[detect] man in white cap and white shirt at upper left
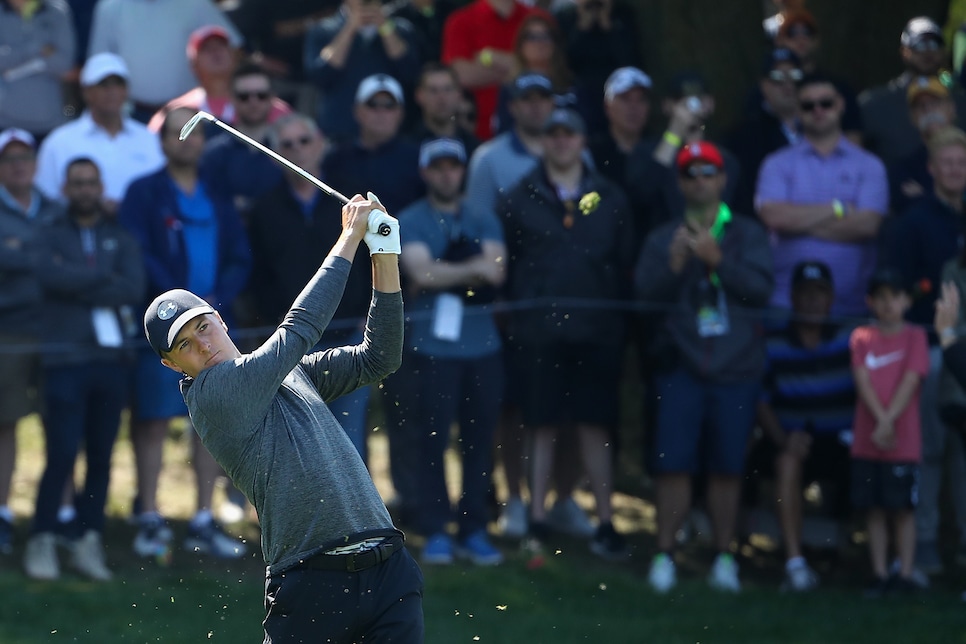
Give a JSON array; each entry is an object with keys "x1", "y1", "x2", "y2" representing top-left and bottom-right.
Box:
[{"x1": 37, "y1": 53, "x2": 164, "y2": 213}]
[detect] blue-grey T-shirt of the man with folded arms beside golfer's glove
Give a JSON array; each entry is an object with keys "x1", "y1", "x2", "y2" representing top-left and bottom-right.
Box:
[{"x1": 399, "y1": 199, "x2": 503, "y2": 358}]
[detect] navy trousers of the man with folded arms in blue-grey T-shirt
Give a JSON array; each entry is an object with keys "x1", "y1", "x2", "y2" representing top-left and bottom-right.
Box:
[{"x1": 413, "y1": 353, "x2": 504, "y2": 537}]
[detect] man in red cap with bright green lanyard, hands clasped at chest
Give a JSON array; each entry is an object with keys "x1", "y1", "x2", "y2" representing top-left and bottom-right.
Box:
[{"x1": 634, "y1": 141, "x2": 773, "y2": 593}]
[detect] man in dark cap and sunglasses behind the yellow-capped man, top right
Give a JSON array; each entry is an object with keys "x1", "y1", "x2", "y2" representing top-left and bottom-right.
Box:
[{"x1": 859, "y1": 16, "x2": 966, "y2": 166}]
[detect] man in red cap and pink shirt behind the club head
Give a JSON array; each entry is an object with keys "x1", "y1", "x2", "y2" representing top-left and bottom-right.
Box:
[{"x1": 148, "y1": 25, "x2": 292, "y2": 132}]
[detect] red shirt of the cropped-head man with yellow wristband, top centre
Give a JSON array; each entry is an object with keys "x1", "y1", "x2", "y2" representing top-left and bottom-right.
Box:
[{"x1": 443, "y1": 0, "x2": 553, "y2": 141}]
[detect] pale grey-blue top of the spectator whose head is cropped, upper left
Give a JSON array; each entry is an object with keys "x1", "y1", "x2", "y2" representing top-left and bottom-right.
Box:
[{"x1": 87, "y1": 0, "x2": 242, "y2": 105}]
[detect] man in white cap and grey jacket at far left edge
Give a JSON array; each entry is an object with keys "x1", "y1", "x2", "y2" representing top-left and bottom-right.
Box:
[{"x1": 0, "y1": 128, "x2": 64, "y2": 552}]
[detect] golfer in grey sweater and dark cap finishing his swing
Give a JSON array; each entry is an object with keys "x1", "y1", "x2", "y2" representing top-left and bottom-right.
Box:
[{"x1": 144, "y1": 193, "x2": 423, "y2": 644}]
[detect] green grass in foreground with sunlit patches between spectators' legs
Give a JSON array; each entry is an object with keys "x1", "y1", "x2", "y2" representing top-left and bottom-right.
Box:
[{"x1": 0, "y1": 412, "x2": 966, "y2": 644}]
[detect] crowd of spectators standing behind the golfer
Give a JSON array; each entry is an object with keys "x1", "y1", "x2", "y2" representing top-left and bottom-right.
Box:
[{"x1": 0, "y1": 0, "x2": 966, "y2": 595}]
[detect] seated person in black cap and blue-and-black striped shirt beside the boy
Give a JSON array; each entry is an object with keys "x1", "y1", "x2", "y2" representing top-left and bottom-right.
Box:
[{"x1": 747, "y1": 260, "x2": 855, "y2": 592}]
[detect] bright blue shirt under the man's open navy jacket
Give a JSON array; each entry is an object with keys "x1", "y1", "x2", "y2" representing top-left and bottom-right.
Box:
[{"x1": 172, "y1": 181, "x2": 218, "y2": 296}]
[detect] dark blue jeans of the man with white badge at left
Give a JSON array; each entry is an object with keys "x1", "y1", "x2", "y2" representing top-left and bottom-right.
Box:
[{"x1": 31, "y1": 362, "x2": 131, "y2": 534}]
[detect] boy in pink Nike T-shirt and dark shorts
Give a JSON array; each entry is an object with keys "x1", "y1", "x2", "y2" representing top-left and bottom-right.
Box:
[{"x1": 849, "y1": 269, "x2": 929, "y2": 596}]
